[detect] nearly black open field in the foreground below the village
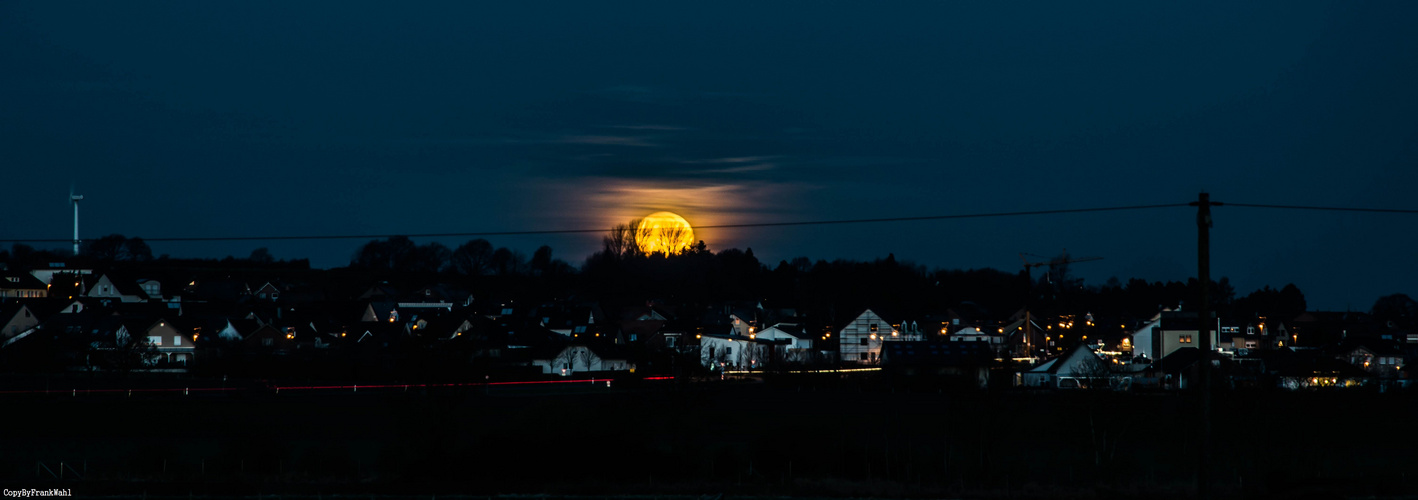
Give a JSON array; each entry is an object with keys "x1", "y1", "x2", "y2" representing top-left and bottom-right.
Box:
[{"x1": 0, "y1": 373, "x2": 1418, "y2": 499}]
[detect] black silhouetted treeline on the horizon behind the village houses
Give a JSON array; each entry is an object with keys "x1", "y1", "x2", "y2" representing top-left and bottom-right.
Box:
[{"x1": 0, "y1": 235, "x2": 1418, "y2": 332}]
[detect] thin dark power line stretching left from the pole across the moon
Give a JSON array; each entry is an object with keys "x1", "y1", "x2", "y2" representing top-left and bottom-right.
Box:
[{"x1": 0, "y1": 203, "x2": 1187, "y2": 244}]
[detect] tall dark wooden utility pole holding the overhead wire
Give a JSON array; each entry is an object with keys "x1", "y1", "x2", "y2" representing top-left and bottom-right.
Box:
[{"x1": 1191, "y1": 193, "x2": 1219, "y2": 500}]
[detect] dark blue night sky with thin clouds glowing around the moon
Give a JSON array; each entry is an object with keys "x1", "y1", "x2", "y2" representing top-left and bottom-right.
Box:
[{"x1": 0, "y1": 1, "x2": 1418, "y2": 310}]
